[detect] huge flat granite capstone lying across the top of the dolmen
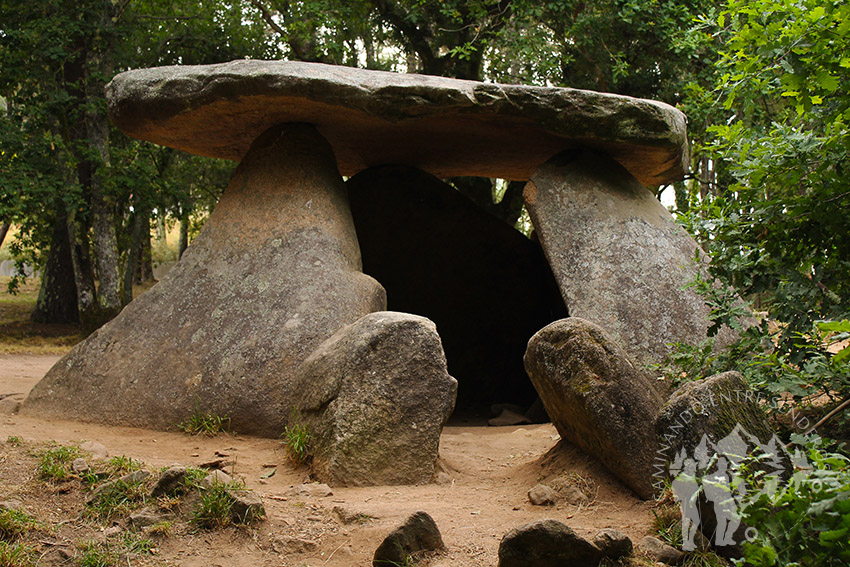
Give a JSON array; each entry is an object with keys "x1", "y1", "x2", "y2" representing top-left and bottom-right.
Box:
[{"x1": 106, "y1": 60, "x2": 687, "y2": 185}]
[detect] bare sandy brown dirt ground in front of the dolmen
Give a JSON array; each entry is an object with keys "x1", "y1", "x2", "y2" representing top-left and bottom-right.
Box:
[{"x1": 0, "y1": 355, "x2": 653, "y2": 567}]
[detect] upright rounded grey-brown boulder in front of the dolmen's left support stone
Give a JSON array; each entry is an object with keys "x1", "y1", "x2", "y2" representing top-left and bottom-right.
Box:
[{"x1": 294, "y1": 312, "x2": 457, "y2": 486}]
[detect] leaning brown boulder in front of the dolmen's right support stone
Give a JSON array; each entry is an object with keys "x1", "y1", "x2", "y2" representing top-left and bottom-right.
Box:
[{"x1": 525, "y1": 317, "x2": 664, "y2": 498}]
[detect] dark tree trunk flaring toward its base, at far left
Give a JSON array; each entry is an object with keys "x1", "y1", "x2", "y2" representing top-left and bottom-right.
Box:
[{"x1": 30, "y1": 207, "x2": 80, "y2": 324}]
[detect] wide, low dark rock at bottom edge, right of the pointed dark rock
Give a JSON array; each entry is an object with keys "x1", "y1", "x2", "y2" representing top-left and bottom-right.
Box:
[{"x1": 499, "y1": 520, "x2": 602, "y2": 567}]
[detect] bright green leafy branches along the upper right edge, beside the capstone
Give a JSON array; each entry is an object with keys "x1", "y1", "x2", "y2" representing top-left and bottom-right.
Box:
[{"x1": 685, "y1": 0, "x2": 850, "y2": 364}]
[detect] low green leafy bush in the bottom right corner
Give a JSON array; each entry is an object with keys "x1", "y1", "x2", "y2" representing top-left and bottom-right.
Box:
[{"x1": 728, "y1": 439, "x2": 850, "y2": 567}]
